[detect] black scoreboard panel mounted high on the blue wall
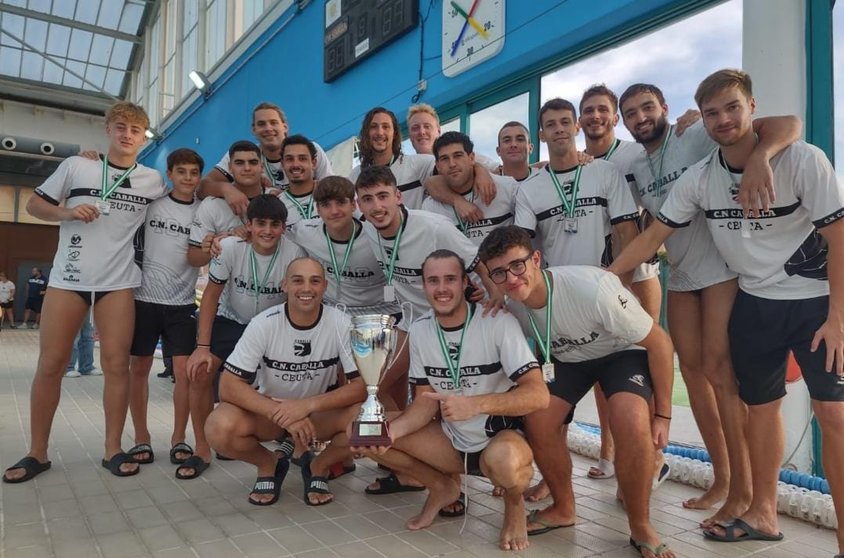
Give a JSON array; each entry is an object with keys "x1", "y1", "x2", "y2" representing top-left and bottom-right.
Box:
[{"x1": 323, "y1": 0, "x2": 419, "y2": 83}]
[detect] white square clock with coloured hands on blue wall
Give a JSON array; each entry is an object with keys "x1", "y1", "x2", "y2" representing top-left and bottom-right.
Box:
[{"x1": 442, "y1": 0, "x2": 504, "y2": 77}]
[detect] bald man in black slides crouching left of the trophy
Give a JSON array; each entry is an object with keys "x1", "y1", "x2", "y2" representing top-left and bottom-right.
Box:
[{"x1": 205, "y1": 258, "x2": 365, "y2": 506}]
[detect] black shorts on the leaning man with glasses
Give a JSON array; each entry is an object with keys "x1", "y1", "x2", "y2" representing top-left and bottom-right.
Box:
[{"x1": 548, "y1": 349, "x2": 653, "y2": 424}]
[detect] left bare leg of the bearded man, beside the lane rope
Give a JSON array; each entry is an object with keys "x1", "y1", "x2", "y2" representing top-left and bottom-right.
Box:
[{"x1": 668, "y1": 291, "x2": 730, "y2": 509}]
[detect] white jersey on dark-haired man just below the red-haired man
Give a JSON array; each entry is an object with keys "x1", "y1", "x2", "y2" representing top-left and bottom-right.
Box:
[{"x1": 422, "y1": 175, "x2": 519, "y2": 246}]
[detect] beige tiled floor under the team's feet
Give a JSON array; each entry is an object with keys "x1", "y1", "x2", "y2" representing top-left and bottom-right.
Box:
[{"x1": 0, "y1": 329, "x2": 836, "y2": 558}]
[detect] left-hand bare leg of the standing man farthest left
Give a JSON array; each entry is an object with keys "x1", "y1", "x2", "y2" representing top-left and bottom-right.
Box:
[{"x1": 6, "y1": 287, "x2": 88, "y2": 480}]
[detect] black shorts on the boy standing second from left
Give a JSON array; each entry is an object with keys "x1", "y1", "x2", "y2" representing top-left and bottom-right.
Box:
[{"x1": 130, "y1": 300, "x2": 196, "y2": 357}]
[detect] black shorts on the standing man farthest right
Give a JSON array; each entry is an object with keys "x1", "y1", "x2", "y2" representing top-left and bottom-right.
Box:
[{"x1": 729, "y1": 290, "x2": 844, "y2": 405}]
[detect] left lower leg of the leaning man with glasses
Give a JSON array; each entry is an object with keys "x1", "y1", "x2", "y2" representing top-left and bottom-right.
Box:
[{"x1": 525, "y1": 396, "x2": 576, "y2": 532}]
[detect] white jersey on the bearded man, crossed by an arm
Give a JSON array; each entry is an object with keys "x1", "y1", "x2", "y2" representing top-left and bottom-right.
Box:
[{"x1": 631, "y1": 121, "x2": 736, "y2": 291}]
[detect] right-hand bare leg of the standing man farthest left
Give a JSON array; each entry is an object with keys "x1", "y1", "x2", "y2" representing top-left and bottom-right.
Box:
[{"x1": 94, "y1": 289, "x2": 138, "y2": 471}]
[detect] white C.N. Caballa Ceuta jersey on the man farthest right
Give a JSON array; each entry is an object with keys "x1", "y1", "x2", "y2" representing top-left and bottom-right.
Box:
[{"x1": 658, "y1": 141, "x2": 844, "y2": 300}]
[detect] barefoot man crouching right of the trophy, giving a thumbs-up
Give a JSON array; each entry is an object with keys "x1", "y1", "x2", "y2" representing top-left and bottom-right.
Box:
[{"x1": 350, "y1": 250, "x2": 549, "y2": 550}]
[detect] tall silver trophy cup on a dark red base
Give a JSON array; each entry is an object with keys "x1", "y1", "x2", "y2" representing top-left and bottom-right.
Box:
[{"x1": 349, "y1": 314, "x2": 397, "y2": 447}]
